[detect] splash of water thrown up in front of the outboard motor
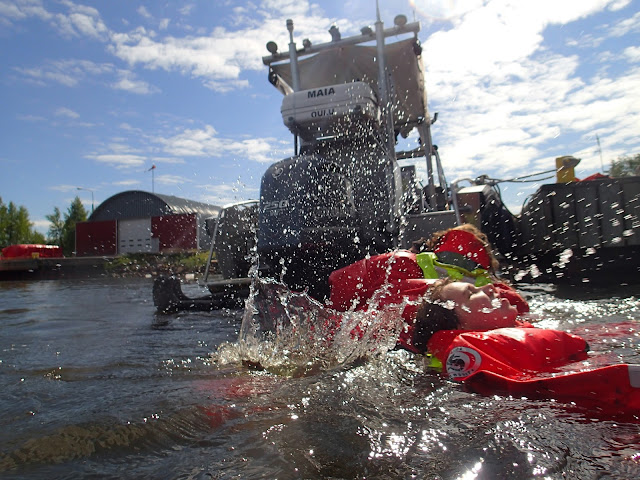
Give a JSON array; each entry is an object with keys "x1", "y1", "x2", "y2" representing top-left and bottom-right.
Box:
[{"x1": 213, "y1": 278, "x2": 405, "y2": 376}]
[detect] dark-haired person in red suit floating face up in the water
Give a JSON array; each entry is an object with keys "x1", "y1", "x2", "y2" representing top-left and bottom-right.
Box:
[{"x1": 413, "y1": 280, "x2": 640, "y2": 412}]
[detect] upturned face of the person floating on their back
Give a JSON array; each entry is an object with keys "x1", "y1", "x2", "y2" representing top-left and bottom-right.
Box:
[{"x1": 441, "y1": 282, "x2": 518, "y2": 330}]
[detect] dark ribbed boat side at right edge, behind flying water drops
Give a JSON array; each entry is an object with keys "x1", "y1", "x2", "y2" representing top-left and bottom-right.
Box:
[{"x1": 503, "y1": 175, "x2": 640, "y2": 285}]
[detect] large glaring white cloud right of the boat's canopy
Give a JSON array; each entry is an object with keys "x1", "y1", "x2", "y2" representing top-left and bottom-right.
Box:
[{"x1": 424, "y1": 0, "x2": 640, "y2": 188}]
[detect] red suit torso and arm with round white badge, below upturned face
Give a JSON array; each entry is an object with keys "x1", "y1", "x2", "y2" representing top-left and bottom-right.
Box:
[{"x1": 428, "y1": 328, "x2": 640, "y2": 414}]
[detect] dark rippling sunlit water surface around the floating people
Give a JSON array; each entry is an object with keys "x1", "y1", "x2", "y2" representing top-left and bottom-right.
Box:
[{"x1": 0, "y1": 278, "x2": 640, "y2": 480}]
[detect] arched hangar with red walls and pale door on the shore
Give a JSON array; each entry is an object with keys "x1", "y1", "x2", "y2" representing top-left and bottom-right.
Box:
[{"x1": 76, "y1": 190, "x2": 221, "y2": 256}]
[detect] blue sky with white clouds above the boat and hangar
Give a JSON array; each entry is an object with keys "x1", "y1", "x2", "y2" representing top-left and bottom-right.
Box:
[{"x1": 0, "y1": 0, "x2": 640, "y2": 234}]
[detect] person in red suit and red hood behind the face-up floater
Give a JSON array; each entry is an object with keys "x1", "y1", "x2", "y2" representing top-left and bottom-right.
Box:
[{"x1": 329, "y1": 225, "x2": 529, "y2": 353}]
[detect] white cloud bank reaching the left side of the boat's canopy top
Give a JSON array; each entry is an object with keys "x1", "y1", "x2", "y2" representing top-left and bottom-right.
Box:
[{"x1": 108, "y1": 0, "x2": 344, "y2": 93}]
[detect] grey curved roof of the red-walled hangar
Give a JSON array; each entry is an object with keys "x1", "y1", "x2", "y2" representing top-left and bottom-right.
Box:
[{"x1": 89, "y1": 190, "x2": 221, "y2": 222}]
